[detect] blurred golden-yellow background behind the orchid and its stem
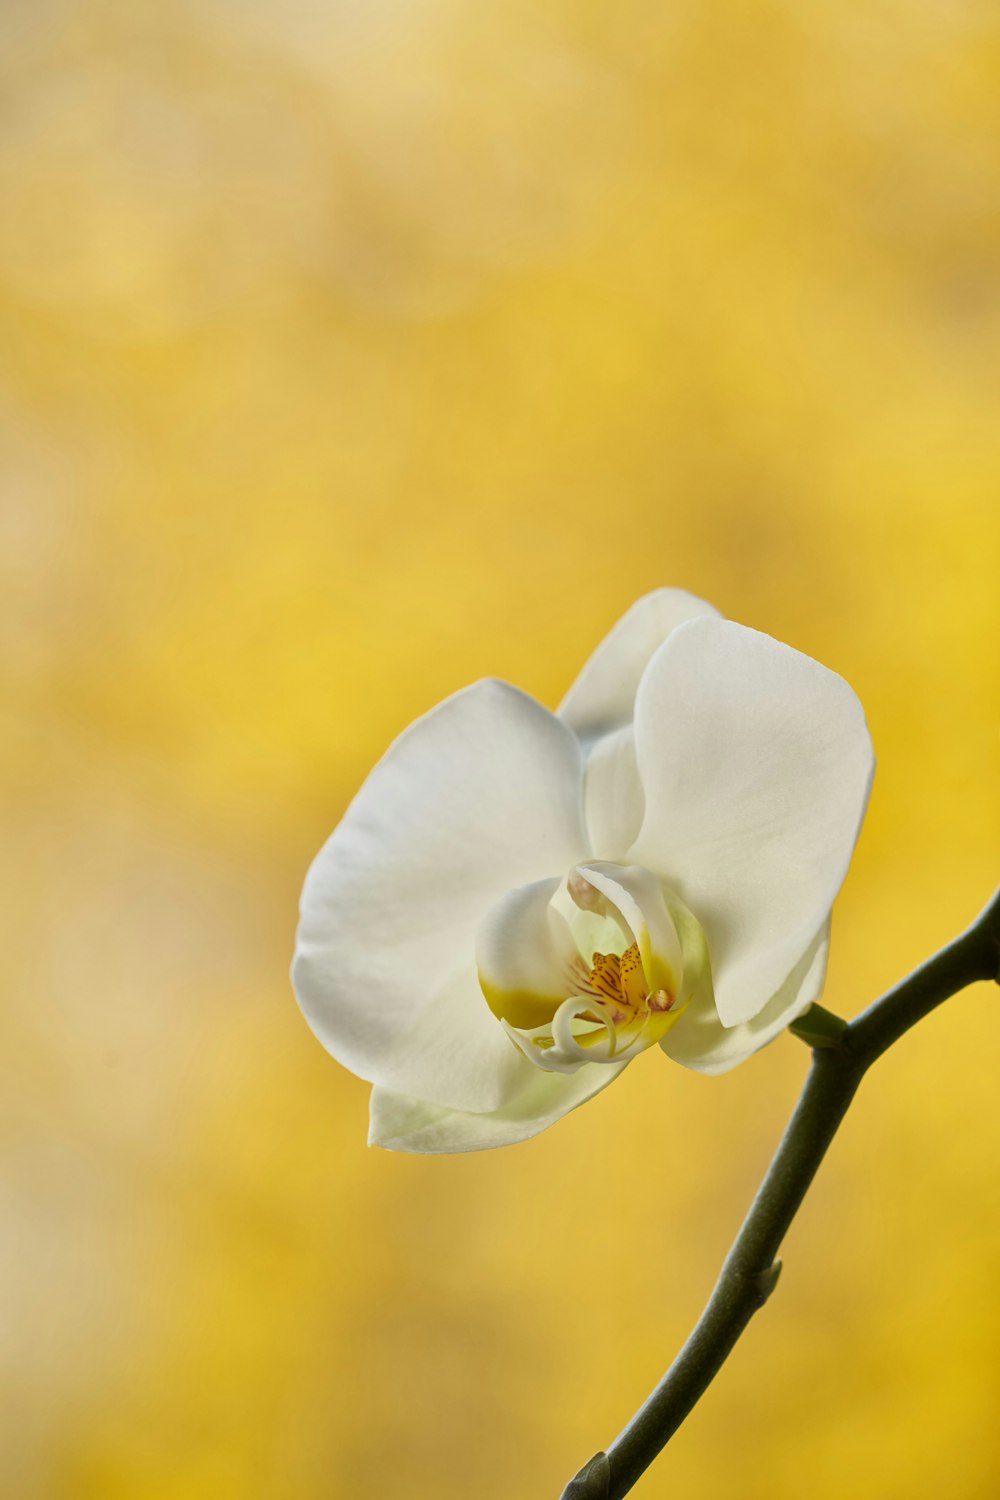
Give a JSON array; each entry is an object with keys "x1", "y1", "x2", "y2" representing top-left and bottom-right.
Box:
[{"x1": 0, "y1": 0, "x2": 1000, "y2": 1500}]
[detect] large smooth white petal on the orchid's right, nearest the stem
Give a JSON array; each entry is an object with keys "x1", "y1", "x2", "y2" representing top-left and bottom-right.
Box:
[{"x1": 630, "y1": 620, "x2": 874, "y2": 1026}]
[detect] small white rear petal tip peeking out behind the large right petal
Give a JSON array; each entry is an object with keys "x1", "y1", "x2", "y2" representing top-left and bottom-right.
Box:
[{"x1": 559, "y1": 588, "x2": 718, "y2": 738}]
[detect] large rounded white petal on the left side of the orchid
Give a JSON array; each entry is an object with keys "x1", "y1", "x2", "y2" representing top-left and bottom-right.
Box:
[{"x1": 292, "y1": 681, "x2": 586, "y2": 1110}]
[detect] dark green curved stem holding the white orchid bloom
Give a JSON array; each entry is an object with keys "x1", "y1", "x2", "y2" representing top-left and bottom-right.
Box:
[{"x1": 564, "y1": 891, "x2": 1000, "y2": 1500}]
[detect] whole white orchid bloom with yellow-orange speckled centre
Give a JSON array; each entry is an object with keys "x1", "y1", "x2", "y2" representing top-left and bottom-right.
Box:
[{"x1": 292, "y1": 590, "x2": 874, "y2": 1152}]
